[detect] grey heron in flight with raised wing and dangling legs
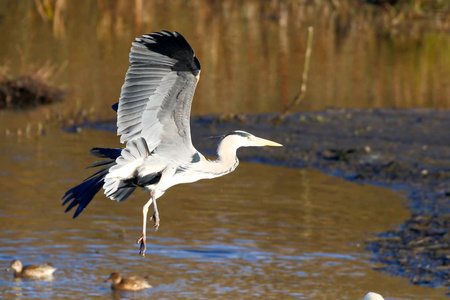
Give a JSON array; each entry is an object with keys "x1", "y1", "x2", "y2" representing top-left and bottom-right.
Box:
[{"x1": 62, "y1": 31, "x2": 282, "y2": 256}]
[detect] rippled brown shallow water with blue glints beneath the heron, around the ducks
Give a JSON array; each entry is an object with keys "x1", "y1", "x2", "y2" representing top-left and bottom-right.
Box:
[{"x1": 0, "y1": 130, "x2": 446, "y2": 299}]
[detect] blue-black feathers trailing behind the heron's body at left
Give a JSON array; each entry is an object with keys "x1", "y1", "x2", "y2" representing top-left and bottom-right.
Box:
[{"x1": 62, "y1": 148, "x2": 135, "y2": 218}]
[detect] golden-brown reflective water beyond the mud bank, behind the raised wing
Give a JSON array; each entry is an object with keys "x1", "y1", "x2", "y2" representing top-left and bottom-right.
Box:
[{"x1": 0, "y1": 0, "x2": 450, "y2": 129}]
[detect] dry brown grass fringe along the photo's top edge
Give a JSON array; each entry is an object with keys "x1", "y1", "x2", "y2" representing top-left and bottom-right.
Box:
[{"x1": 29, "y1": 0, "x2": 450, "y2": 37}]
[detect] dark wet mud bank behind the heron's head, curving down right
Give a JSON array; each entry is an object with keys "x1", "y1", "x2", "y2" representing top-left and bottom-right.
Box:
[{"x1": 77, "y1": 109, "x2": 450, "y2": 286}]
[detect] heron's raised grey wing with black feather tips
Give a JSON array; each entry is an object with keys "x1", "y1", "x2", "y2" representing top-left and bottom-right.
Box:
[{"x1": 117, "y1": 31, "x2": 200, "y2": 157}]
